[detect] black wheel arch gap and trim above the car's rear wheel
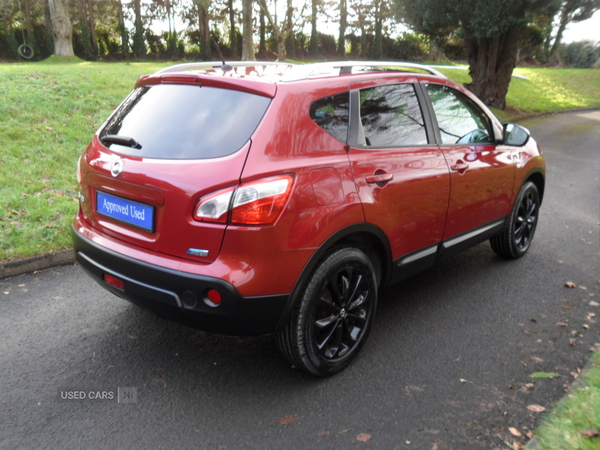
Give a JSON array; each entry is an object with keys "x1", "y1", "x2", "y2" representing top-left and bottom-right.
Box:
[{"x1": 277, "y1": 223, "x2": 392, "y2": 331}]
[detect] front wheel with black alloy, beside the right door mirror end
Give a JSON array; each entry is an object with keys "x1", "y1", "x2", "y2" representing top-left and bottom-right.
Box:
[{"x1": 490, "y1": 181, "x2": 540, "y2": 259}]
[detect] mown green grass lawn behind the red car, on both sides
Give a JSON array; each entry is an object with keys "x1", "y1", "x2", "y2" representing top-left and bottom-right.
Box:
[{"x1": 0, "y1": 57, "x2": 600, "y2": 261}]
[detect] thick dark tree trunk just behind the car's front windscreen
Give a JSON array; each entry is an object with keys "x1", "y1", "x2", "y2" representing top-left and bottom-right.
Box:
[{"x1": 465, "y1": 29, "x2": 520, "y2": 110}]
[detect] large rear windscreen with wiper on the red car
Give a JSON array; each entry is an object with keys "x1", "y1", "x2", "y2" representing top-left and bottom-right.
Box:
[{"x1": 99, "y1": 84, "x2": 271, "y2": 159}]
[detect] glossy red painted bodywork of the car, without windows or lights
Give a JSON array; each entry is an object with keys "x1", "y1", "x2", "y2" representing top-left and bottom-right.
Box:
[{"x1": 74, "y1": 63, "x2": 543, "y2": 302}]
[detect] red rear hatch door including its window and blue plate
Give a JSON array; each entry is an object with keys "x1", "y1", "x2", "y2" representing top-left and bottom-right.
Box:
[{"x1": 80, "y1": 84, "x2": 270, "y2": 262}]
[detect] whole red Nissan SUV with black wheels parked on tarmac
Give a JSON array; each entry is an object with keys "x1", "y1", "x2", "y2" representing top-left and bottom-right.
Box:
[{"x1": 73, "y1": 61, "x2": 545, "y2": 375}]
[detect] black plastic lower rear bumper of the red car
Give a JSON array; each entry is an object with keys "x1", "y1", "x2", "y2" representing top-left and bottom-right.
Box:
[{"x1": 71, "y1": 227, "x2": 289, "y2": 335}]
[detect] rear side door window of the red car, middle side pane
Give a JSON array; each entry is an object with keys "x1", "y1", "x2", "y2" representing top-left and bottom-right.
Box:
[{"x1": 360, "y1": 84, "x2": 427, "y2": 147}]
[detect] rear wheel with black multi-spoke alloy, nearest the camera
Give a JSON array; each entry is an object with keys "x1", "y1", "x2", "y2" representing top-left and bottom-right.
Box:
[{"x1": 276, "y1": 248, "x2": 377, "y2": 376}]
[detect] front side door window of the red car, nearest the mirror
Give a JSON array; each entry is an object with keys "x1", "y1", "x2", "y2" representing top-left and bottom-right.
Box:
[{"x1": 427, "y1": 84, "x2": 493, "y2": 144}]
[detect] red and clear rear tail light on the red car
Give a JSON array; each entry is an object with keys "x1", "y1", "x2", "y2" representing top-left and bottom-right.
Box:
[{"x1": 194, "y1": 175, "x2": 294, "y2": 225}]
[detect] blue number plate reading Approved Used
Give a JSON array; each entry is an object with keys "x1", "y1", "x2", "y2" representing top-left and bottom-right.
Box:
[{"x1": 96, "y1": 191, "x2": 154, "y2": 232}]
